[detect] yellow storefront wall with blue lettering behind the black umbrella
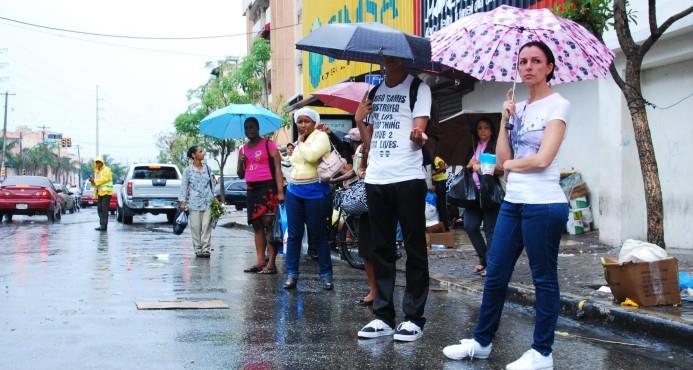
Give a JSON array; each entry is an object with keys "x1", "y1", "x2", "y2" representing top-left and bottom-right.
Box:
[{"x1": 303, "y1": 0, "x2": 414, "y2": 114}]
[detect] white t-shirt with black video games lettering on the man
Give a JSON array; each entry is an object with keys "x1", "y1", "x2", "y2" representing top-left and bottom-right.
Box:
[{"x1": 365, "y1": 75, "x2": 431, "y2": 184}]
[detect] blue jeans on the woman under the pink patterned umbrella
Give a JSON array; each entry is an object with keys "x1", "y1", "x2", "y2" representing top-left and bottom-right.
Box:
[{"x1": 474, "y1": 202, "x2": 568, "y2": 356}]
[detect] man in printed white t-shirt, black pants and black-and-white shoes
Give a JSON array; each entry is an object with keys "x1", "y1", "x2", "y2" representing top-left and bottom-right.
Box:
[{"x1": 355, "y1": 57, "x2": 431, "y2": 342}]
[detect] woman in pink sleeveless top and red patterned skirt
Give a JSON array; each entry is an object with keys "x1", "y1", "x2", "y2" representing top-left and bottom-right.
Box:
[{"x1": 237, "y1": 117, "x2": 284, "y2": 274}]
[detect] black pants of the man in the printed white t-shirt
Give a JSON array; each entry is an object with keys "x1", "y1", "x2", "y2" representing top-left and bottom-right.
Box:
[{"x1": 366, "y1": 180, "x2": 429, "y2": 328}]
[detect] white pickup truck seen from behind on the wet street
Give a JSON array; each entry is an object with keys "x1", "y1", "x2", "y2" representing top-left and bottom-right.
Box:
[{"x1": 116, "y1": 163, "x2": 181, "y2": 225}]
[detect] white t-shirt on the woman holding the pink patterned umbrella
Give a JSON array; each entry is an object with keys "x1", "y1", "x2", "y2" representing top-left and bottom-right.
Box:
[{"x1": 505, "y1": 93, "x2": 570, "y2": 204}]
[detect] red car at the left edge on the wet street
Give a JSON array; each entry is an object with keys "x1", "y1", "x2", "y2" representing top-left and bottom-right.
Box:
[{"x1": 0, "y1": 176, "x2": 60, "y2": 222}]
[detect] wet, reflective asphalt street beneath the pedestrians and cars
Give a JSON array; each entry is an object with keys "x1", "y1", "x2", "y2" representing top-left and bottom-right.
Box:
[{"x1": 0, "y1": 208, "x2": 693, "y2": 369}]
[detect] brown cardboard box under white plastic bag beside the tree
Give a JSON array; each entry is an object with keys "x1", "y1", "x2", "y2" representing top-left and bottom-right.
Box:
[{"x1": 602, "y1": 256, "x2": 681, "y2": 306}]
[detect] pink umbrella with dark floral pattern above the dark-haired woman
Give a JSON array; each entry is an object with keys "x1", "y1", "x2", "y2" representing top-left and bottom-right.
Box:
[{"x1": 430, "y1": 5, "x2": 614, "y2": 84}]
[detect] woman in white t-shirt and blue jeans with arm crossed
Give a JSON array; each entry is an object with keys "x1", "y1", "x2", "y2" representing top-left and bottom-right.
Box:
[{"x1": 443, "y1": 41, "x2": 570, "y2": 369}]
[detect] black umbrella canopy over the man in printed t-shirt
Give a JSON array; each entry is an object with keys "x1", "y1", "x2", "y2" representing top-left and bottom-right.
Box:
[{"x1": 296, "y1": 23, "x2": 433, "y2": 69}]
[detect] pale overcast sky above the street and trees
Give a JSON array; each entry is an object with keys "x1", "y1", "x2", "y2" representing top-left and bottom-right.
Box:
[{"x1": 0, "y1": 0, "x2": 246, "y2": 163}]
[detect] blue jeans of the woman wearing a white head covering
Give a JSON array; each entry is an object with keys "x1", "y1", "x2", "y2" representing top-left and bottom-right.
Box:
[{"x1": 284, "y1": 191, "x2": 332, "y2": 281}]
